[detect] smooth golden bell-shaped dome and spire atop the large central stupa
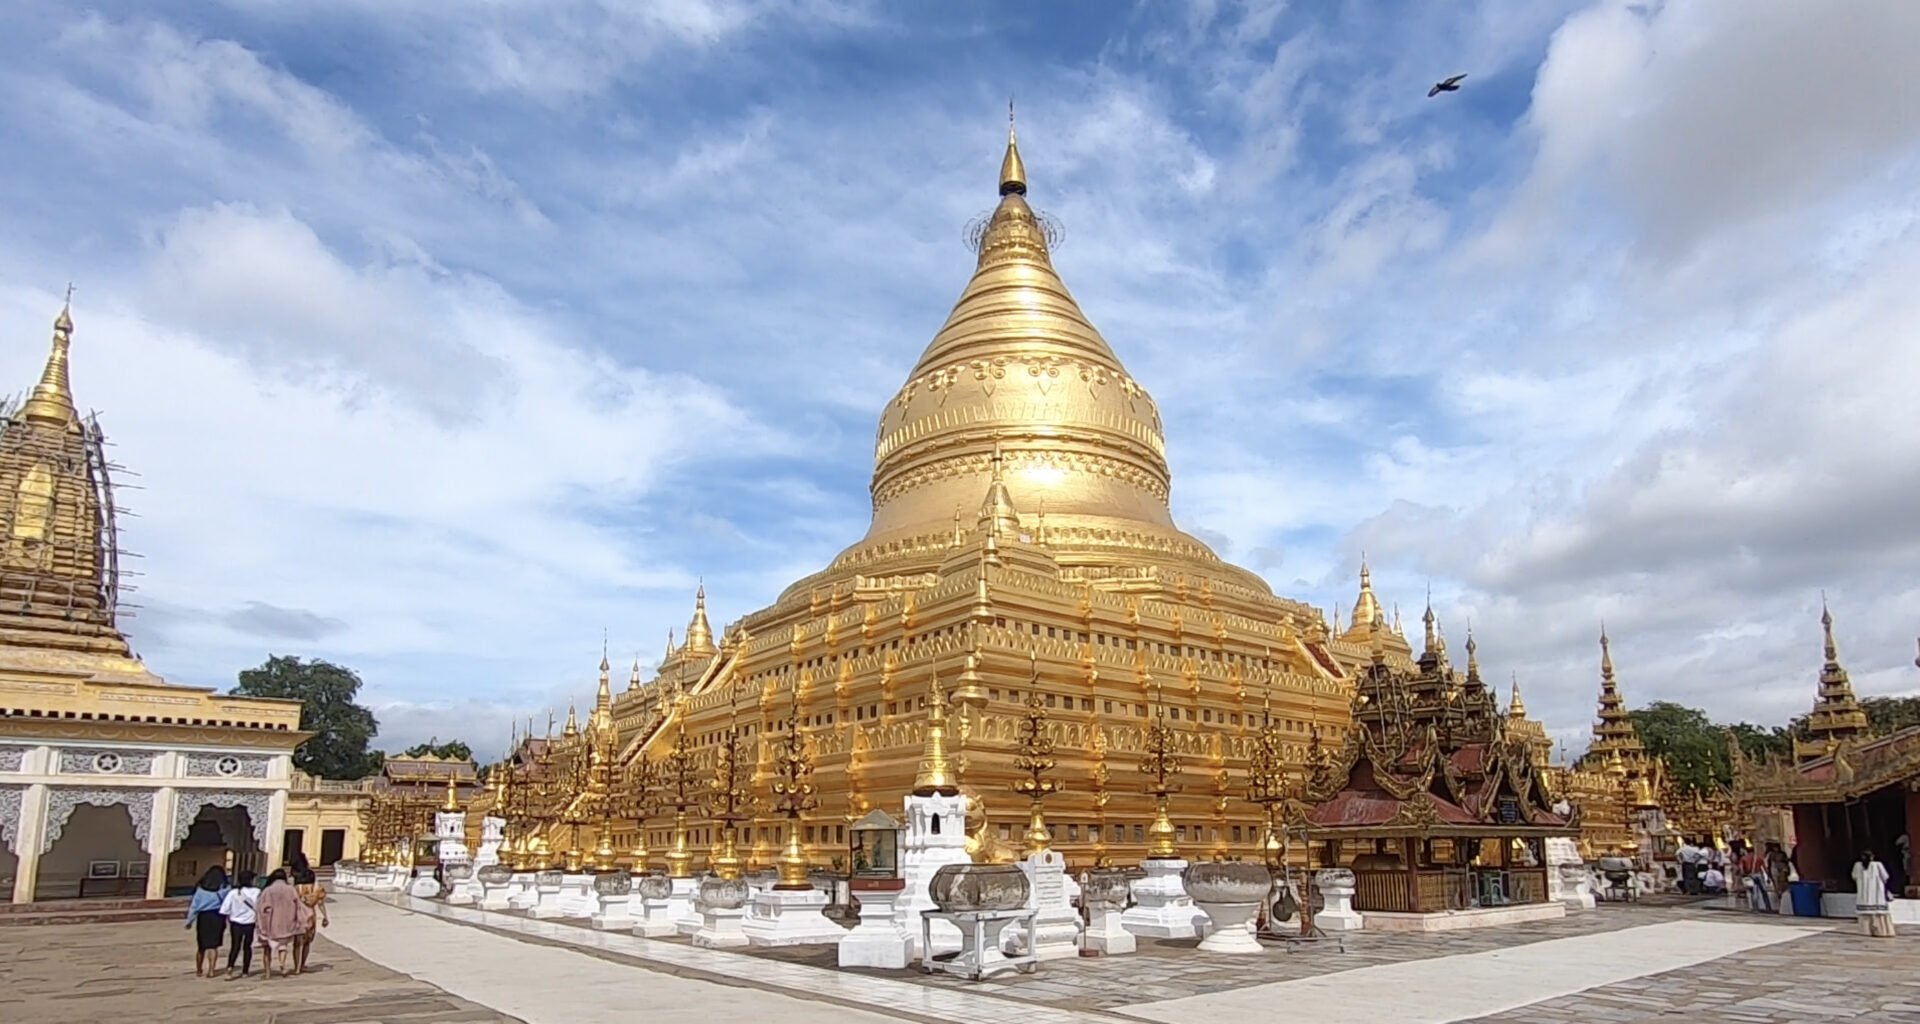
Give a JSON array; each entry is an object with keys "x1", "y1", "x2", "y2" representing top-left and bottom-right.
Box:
[{"x1": 797, "y1": 125, "x2": 1269, "y2": 594}]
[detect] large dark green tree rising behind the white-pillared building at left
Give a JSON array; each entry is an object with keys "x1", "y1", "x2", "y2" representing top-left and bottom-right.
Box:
[{"x1": 232, "y1": 655, "x2": 380, "y2": 780}]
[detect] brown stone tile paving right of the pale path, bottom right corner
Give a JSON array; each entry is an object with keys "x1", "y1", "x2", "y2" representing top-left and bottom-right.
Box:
[{"x1": 1451, "y1": 922, "x2": 1920, "y2": 1024}]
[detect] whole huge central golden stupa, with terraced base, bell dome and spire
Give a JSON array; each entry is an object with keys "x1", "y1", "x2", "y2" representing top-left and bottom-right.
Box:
[{"x1": 526, "y1": 123, "x2": 1409, "y2": 866}]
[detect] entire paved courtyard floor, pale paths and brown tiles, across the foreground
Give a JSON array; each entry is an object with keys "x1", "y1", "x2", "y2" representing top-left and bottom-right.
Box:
[{"x1": 0, "y1": 895, "x2": 1920, "y2": 1024}]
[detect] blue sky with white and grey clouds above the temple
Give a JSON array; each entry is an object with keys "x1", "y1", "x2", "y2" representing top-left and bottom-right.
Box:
[{"x1": 0, "y1": 0, "x2": 1920, "y2": 749}]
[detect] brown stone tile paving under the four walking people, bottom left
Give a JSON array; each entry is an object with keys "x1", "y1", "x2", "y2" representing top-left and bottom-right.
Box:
[{"x1": 0, "y1": 920, "x2": 518, "y2": 1024}]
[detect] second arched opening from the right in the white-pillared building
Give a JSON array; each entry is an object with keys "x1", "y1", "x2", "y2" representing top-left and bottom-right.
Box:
[{"x1": 33, "y1": 790, "x2": 154, "y2": 899}]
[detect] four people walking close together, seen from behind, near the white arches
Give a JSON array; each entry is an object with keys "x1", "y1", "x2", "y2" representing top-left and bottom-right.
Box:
[{"x1": 186, "y1": 853, "x2": 328, "y2": 978}]
